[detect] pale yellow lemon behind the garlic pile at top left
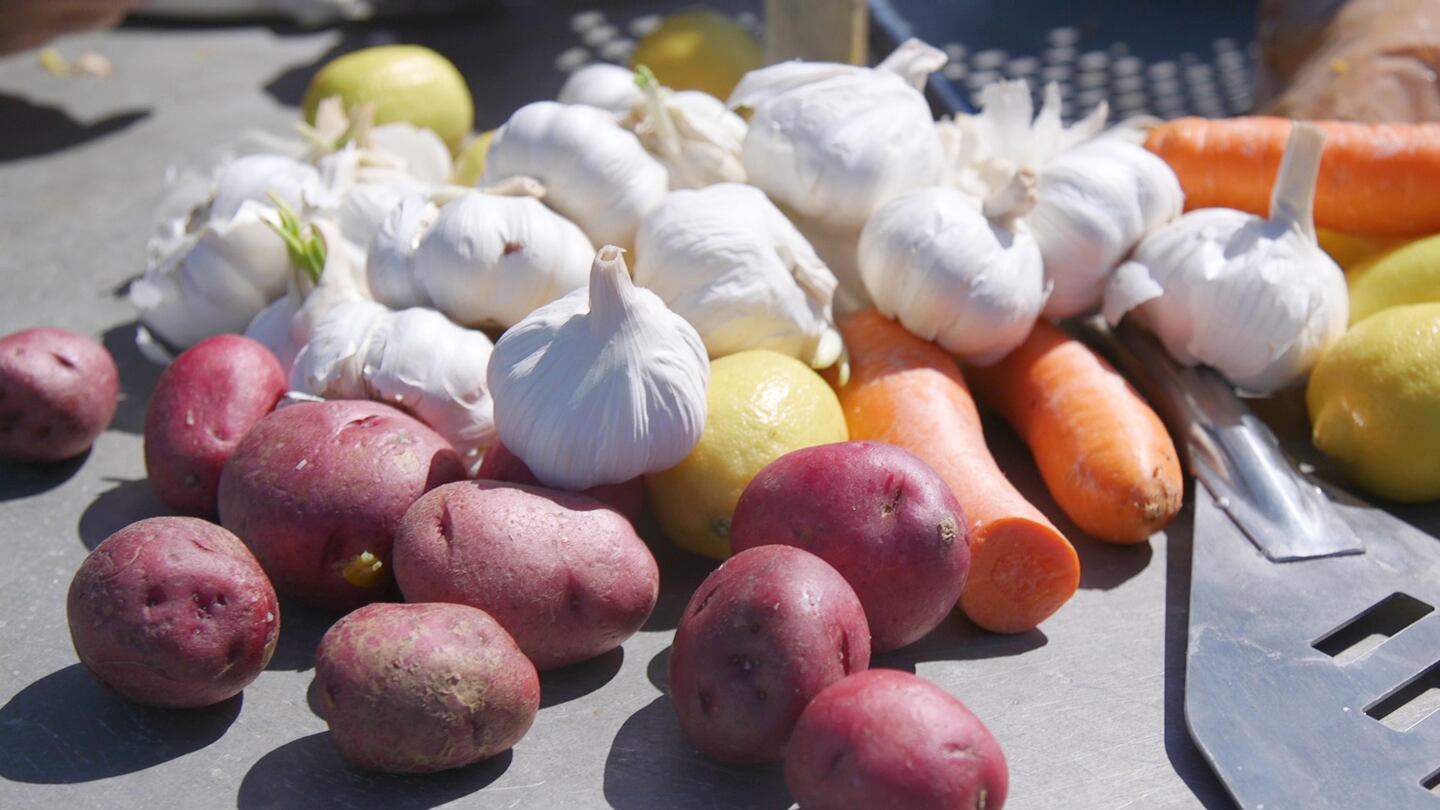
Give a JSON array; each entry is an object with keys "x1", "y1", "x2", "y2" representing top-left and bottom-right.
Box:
[{"x1": 302, "y1": 45, "x2": 475, "y2": 151}]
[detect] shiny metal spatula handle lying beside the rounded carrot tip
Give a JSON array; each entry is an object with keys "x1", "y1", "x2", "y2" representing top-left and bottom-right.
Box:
[{"x1": 1086, "y1": 321, "x2": 1364, "y2": 562}]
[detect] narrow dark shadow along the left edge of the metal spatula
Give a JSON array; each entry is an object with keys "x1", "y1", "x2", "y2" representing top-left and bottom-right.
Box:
[{"x1": 1164, "y1": 502, "x2": 1234, "y2": 810}]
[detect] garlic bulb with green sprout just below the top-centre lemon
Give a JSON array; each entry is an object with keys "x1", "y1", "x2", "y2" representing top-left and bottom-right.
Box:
[{"x1": 622, "y1": 68, "x2": 747, "y2": 189}]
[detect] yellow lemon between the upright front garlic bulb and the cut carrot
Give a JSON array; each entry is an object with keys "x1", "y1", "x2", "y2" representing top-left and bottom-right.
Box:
[{"x1": 645, "y1": 349, "x2": 850, "y2": 559}]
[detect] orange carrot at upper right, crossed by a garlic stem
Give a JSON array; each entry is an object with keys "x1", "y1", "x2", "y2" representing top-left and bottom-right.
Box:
[{"x1": 1145, "y1": 117, "x2": 1440, "y2": 236}]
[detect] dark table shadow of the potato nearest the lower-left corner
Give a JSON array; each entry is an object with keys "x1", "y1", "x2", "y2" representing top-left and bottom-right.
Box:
[{"x1": 0, "y1": 663, "x2": 242, "y2": 784}]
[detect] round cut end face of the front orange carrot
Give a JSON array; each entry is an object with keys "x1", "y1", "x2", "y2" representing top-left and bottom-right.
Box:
[{"x1": 960, "y1": 517, "x2": 1080, "y2": 633}]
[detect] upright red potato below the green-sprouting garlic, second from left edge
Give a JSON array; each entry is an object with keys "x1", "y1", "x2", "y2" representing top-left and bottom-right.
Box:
[{"x1": 145, "y1": 334, "x2": 285, "y2": 517}]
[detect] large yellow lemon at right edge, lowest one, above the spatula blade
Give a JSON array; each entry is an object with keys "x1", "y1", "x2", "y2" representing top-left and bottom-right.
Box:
[{"x1": 1305, "y1": 304, "x2": 1440, "y2": 502}]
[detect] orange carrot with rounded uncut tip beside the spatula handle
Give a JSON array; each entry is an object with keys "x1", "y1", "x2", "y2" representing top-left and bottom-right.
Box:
[{"x1": 965, "y1": 321, "x2": 1185, "y2": 543}]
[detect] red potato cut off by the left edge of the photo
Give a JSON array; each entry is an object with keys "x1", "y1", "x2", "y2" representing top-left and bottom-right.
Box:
[{"x1": 0, "y1": 327, "x2": 120, "y2": 463}]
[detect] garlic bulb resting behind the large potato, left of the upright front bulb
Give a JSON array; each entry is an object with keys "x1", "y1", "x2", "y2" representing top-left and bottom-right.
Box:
[{"x1": 289, "y1": 301, "x2": 495, "y2": 473}]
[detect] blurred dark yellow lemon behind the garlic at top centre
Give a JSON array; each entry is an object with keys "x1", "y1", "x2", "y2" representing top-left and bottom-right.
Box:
[{"x1": 631, "y1": 9, "x2": 763, "y2": 101}]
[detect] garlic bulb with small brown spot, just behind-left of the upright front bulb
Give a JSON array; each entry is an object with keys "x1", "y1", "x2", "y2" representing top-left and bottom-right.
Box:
[{"x1": 413, "y1": 192, "x2": 595, "y2": 327}]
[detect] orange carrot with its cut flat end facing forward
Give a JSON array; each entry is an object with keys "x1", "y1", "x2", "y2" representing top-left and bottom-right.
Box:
[{"x1": 837, "y1": 310, "x2": 1080, "y2": 633}]
